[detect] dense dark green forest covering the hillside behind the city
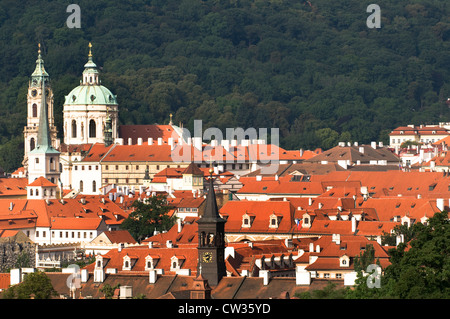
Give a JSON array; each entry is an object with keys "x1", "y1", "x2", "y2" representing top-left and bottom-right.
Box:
[{"x1": 0, "y1": 0, "x2": 450, "y2": 171}]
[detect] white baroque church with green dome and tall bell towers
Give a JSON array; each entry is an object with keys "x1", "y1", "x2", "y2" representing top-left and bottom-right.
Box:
[{"x1": 22, "y1": 43, "x2": 160, "y2": 198}]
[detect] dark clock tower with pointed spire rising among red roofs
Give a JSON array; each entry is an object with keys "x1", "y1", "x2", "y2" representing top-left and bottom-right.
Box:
[{"x1": 197, "y1": 171, "x2": 226, "y2": 286}]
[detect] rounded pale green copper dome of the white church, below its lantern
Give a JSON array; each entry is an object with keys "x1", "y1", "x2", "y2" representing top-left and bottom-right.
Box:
[{"x1": 64, "y1": 84, "x2": 117, "y2": 105}]
